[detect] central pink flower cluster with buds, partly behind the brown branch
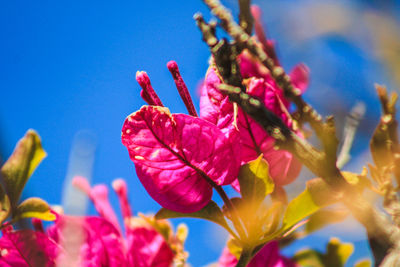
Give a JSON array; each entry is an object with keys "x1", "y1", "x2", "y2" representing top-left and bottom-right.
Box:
[{"x1": 122, "y1": 5, "x2": 308, "y2": 213}]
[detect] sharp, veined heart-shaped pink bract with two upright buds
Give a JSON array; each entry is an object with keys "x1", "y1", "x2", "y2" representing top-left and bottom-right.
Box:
[{"x1": 122, "y1": 61, "x2": 240, "y2": 213}]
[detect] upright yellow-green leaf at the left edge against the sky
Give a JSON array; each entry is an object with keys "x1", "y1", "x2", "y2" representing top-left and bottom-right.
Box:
[{"x1": 1, "y1": 130, "x2": 46, "y2": 207}]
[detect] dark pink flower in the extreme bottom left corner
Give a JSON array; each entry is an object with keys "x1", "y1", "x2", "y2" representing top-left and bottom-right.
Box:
[{"x1": 0, "y1": 227, "x2": 62, "y2": 267}]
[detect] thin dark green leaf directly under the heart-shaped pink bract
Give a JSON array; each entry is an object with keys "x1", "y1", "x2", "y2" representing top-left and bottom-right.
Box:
[{"x1": 155, "y1": 201, "x2": 229, "y2": 229}]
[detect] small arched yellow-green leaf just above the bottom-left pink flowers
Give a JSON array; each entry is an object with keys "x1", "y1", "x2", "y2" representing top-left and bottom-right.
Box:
[{"x1": 13, "y1": 197, "x2": 56, "y2": 221}]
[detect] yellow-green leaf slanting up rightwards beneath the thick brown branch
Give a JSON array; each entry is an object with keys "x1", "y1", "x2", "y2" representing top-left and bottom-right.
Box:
[{"x1": 282, "y1": 178, "x2": 339, "y2": 232}]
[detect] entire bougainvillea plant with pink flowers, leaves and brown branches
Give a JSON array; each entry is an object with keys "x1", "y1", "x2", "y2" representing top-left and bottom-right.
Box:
[{"x1": 0, "y1": 0, "x2": 400, "y2": 267}]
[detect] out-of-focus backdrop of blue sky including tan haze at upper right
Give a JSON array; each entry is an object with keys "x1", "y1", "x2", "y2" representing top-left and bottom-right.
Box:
[{"x1": 0, "y1": 0, "x2": 400, "y2": 266}]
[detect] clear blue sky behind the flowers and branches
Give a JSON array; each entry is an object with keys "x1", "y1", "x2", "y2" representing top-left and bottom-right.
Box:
[{"x1": 0, "y1": 0, "x2": 393, "y2": 266}]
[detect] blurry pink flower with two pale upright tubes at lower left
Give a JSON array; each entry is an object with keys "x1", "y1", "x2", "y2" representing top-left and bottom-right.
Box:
[{"x1": 63, "y1": 177, "x2": 176, "y2": 267}]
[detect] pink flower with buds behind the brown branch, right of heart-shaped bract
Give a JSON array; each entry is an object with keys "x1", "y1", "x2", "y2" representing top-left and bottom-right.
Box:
[{"x1": 200, "y1": 8, "x2": 308, "y2": 188}]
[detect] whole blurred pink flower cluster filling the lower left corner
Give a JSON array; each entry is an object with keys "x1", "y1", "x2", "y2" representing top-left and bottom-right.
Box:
[{"x1": 0, "y1": 177, "x2": 186, "y2": 267}]
